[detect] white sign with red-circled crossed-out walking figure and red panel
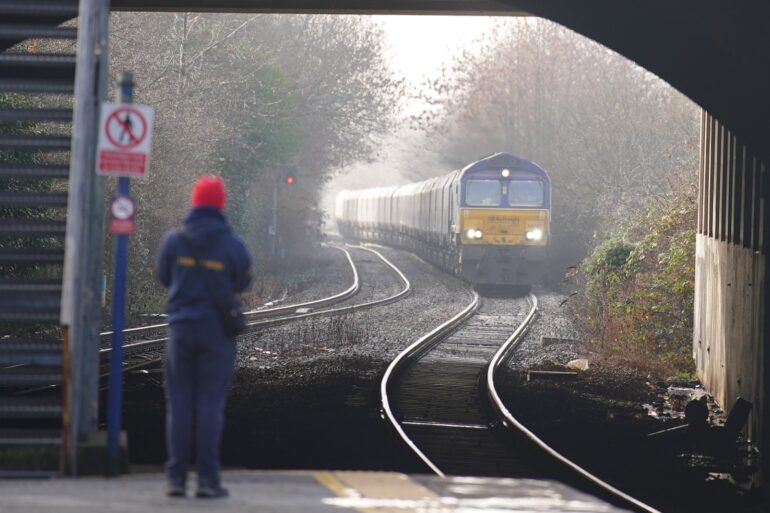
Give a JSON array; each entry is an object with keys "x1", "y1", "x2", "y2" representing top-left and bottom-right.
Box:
[{"x1": 96, "y1": 102, "x2": 154, "y2": 178}]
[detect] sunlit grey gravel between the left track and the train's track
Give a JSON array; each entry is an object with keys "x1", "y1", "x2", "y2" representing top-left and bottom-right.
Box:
[{"x1": 238, "y1": 248, "x2": 471, "y2": 369}]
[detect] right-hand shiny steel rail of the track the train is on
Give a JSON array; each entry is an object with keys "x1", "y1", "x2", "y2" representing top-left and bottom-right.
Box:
[{"x1": 486, "y1": 294, "x2": 660, "y2": 513}]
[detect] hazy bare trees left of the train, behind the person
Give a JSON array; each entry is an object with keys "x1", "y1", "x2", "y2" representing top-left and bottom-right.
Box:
[{"x1": 105, "y1": 13, "x2": 404, "y2": 316}]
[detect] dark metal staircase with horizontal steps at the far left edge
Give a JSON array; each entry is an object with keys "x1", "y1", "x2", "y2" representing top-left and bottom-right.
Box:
[{"x1": 0, "y1": 0, "x2": 78, "y2": 477}]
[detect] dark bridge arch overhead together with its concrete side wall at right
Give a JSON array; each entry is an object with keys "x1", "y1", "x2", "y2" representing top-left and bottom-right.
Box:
[{"x1": 112, "y1": 0, "x2": 770, "y2": 476}]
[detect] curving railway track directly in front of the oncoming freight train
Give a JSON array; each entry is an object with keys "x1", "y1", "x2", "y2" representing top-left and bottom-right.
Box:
[{"x1": 380, "y1": 292, "x2": 658, "y2": 513}]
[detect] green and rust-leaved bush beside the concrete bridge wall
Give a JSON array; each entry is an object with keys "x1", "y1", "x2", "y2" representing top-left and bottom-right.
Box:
[{"x1": 578, "y1": 198, "x2": 696, "y2": 375}]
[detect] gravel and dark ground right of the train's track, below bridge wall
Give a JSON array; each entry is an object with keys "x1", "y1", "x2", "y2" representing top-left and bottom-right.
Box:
[{"x1": 498, "y1": 291, "x2": 763, "y2": 513}]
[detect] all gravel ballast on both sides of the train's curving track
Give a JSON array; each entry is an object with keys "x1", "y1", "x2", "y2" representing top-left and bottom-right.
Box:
[{"x1": 118, "y1": 244, "x2": 759, "y2": 512}]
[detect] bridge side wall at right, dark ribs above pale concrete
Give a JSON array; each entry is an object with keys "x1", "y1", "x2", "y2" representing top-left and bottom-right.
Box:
[{"x1": 693, "y1": 112, "x2": 770, "y2": 482}]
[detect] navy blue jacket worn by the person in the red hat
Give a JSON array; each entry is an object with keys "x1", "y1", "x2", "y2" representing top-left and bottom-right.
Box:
[{"x1": 155, "y1": 207, "x2": 251, "y2": 324}]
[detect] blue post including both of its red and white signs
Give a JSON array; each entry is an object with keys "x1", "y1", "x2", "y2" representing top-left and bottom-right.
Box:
[{"x1": 103, "y1": 71, "x2": 153, "y2": 476}]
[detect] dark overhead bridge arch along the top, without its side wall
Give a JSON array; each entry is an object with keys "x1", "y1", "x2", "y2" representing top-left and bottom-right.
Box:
[{"x1": 111, "y1": 0, "x2": 770, "y2": 162}]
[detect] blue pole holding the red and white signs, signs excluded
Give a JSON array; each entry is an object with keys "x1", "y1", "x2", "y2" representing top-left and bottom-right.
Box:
[{"x1": 107, "y1": 71, "x2": 134, "y2": 476}]
